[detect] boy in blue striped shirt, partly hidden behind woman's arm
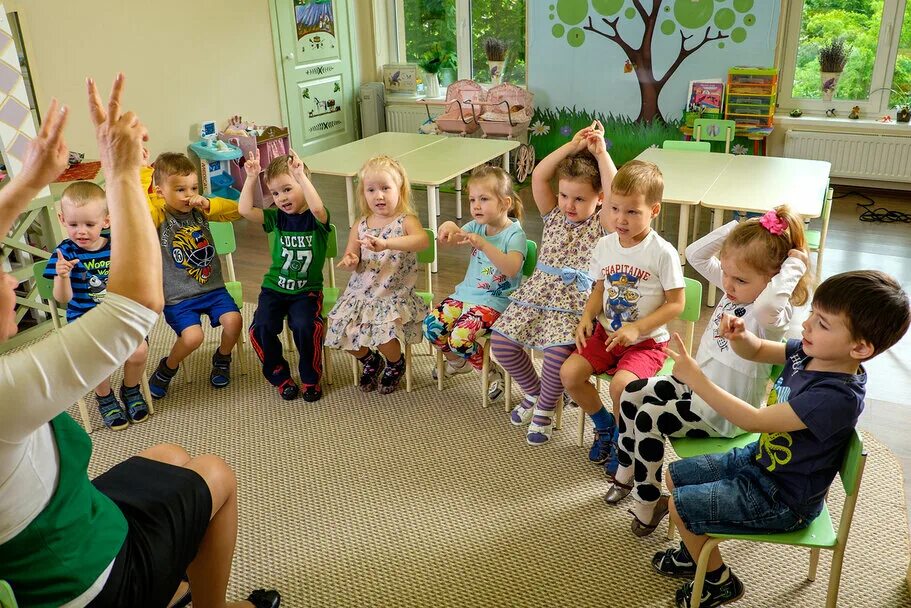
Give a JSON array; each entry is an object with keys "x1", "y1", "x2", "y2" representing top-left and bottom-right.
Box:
[{"x1": 44, "y1": 182, "x2": 149, "y2": 431}]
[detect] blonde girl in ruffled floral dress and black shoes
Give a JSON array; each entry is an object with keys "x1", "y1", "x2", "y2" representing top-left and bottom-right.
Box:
[{"x1": 325, "y1": 156, "x2": 430, "y2": 394}]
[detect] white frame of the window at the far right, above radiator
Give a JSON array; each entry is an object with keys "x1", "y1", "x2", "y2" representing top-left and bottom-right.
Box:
[{"x1": 778, "y1": 0, "x2": 906, "y2": 116}]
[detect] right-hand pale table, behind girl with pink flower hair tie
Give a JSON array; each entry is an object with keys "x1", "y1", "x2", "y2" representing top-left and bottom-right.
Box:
[{"x1": 702, "y1": 156, "x2": 832, "y2": 306}]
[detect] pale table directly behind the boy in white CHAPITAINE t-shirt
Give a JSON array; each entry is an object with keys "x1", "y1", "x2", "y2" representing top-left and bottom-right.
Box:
[{"x1": 636, "y1": 148, "x2": 734, "y2": 264}]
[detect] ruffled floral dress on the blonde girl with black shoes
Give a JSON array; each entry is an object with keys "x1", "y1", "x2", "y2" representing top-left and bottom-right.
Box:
[{"x1": 326, "y1": 215, "x2": 427, "y2": 350}]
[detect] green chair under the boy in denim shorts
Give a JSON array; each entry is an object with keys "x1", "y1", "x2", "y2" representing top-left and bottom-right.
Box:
[{"x1": 692, "y1": 430, "x2": 867, "y2": 608}]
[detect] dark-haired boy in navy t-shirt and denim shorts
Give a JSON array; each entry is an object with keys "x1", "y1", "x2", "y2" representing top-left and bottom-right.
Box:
[{"x1": 652, "y1": 270, "x2": 911, "y2": 608}]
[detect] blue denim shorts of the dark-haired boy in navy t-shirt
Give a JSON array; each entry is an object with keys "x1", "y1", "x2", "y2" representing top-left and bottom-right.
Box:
[{"x1": 668, "y1": 443, "x2": 814, "y2": 534}]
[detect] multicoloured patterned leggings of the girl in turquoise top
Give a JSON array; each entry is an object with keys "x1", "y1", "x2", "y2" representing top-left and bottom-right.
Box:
[{"x1": 424, "y1": 298, "x2": 500, "y2": 369}]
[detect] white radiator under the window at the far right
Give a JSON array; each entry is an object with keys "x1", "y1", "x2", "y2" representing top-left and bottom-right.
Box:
[{"x1": 784, "y1": 130, "x2": 911, "y2": 183}]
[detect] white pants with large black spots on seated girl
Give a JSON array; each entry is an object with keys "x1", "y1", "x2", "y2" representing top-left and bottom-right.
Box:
[{"x1": 615, "y1": 376, "x2": 718, "y2": 511}]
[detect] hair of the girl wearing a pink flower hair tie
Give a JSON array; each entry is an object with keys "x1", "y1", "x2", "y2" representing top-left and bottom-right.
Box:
[{"x1": 720, "y1": 205, "x2": 810, "y2": 306}]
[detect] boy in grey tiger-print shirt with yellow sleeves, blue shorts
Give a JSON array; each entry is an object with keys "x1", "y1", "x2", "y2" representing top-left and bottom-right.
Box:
[{"x1": 140, "y1": 152, "x2": 243, "y2": 399}]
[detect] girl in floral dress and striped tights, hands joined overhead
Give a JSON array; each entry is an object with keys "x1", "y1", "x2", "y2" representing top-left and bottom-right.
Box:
[{"x1": 491, "y1": 121, "x2": 617, "y2": 445}]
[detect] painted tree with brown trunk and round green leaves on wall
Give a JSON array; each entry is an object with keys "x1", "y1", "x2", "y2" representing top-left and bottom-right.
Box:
[{"x1": 550, "y1": 0, "x2": 756, "y2": 122}]
